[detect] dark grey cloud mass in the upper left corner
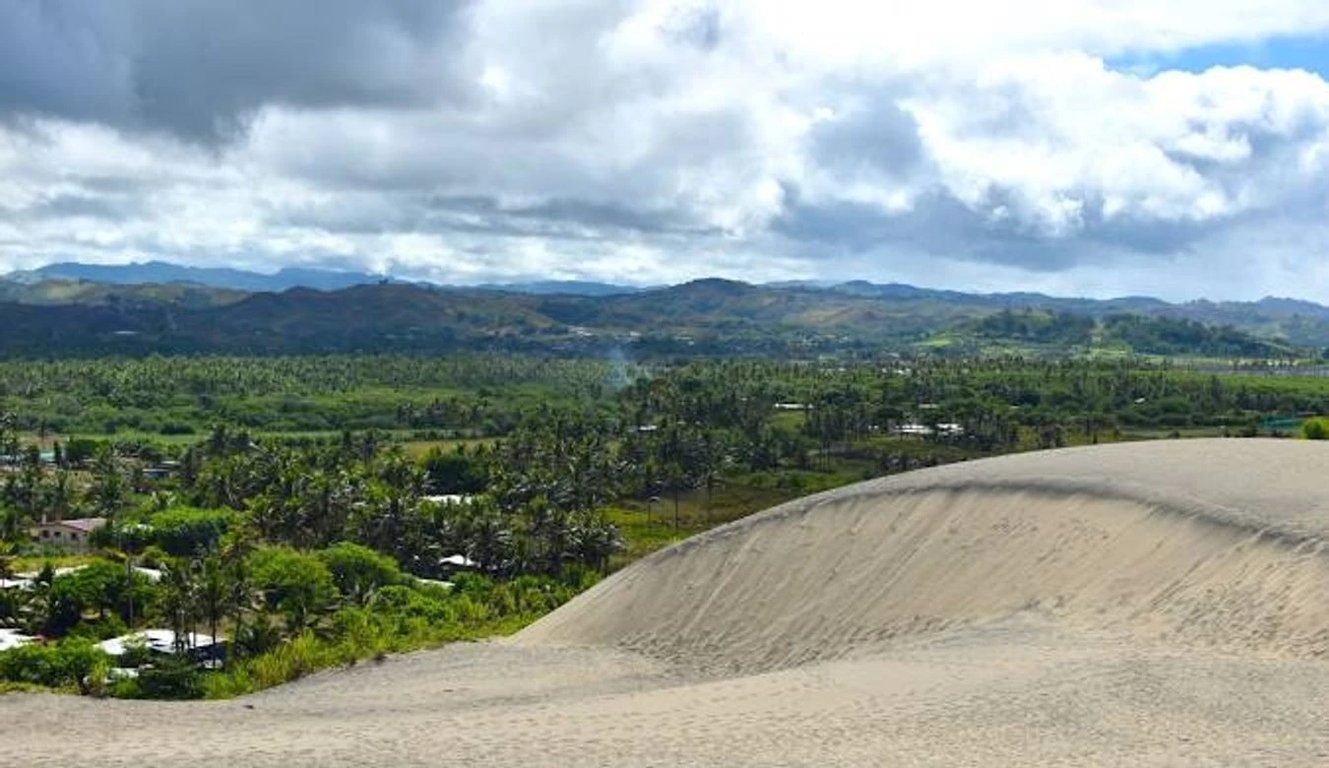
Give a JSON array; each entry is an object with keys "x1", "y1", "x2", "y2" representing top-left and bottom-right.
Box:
[{"x1": 0, "y1": 0, "x2": 470, "y2": 142}]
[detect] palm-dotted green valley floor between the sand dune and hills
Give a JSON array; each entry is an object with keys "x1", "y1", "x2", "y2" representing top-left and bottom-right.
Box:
[{"x1": 0, "y1": 350, "x2": 1329, "y2": 698}]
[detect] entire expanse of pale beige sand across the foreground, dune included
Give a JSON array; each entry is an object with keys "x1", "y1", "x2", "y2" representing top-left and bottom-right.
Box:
[{"x1": 0, "y1": 440, "x2": 1329, "y2": 767}]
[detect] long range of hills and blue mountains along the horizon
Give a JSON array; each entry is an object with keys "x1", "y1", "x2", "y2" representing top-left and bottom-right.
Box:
[{"x1": 0, "y1": 262, "x2": 1329, "y2": 356}]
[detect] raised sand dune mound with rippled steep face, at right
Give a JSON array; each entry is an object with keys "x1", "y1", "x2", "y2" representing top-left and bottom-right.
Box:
[{"x1": 520, "y1": 441, "x2": 1329, "y2": 672}]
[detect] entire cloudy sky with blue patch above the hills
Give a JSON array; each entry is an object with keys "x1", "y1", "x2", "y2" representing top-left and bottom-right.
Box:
[{"x1": 0, "y1": 0, "x2": 1329, "y2": 302}]
